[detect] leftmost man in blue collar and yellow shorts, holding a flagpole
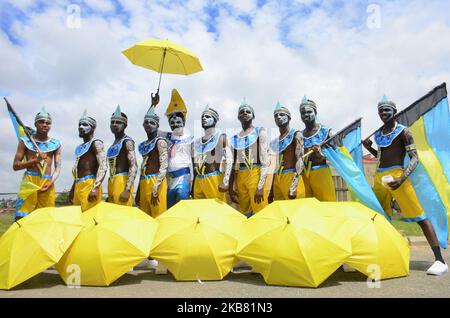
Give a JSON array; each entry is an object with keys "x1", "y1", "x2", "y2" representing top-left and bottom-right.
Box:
[{"x1": 13, "y1": 108, "x2": 61, "y2": 221}]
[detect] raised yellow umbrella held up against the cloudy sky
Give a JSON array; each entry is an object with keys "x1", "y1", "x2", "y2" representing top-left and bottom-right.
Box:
[{"x1": 122, "y1": 39, "x2": 203, "y2": 94}]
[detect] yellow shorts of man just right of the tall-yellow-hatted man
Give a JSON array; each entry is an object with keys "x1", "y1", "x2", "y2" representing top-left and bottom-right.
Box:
[{"x1": 194, "y1": 171, "x2": 226, "y2": 202}]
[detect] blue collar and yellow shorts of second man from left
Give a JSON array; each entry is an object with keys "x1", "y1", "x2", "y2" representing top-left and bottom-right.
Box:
[{"x1": 72, "y1": 139, "x2": 102, "y2": 212}]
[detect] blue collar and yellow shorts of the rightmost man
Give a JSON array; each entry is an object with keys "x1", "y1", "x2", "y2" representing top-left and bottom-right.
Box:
[{"x1": 373, "y1": 124, "x2": 426, "y2": 222}]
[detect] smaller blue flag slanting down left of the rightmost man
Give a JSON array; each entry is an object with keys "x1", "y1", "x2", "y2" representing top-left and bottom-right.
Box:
[{"x1": 322, "y1": 118, "x2": 389, "y2": 219}]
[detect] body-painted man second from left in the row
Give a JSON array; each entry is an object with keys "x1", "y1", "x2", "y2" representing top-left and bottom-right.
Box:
[{"x1": 69, "y1": 111, "x2": 108, "y2": 211}]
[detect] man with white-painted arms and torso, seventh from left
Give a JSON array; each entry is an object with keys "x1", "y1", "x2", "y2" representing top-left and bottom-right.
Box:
[{"x1": 229, "y1": 100, "x2": 269, "y2": 217}]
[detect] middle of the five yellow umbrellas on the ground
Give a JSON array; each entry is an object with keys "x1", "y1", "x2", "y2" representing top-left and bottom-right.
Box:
[{"x1": 150, "y1": 199, "x2": 245, "y2": 280}]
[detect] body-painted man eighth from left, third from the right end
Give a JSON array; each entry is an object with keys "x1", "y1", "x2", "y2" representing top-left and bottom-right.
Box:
[{"x1": 269, "y1": 102, "x2": 305, "y2": 202}]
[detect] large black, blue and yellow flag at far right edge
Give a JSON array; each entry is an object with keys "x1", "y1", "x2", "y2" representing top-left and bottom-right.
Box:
[{"x1": 396, "y1": 83, "x2": 450, "y2": 248}]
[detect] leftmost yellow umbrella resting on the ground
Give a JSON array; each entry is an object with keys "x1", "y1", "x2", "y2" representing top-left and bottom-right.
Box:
[{"x1": 0, "y1": 206, "x2": 83, "y2": 289}]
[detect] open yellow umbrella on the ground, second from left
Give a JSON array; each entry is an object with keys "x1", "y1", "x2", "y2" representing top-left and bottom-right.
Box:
[{"x1": 56, "y1": 202, "x2": 157, "y2": 286}]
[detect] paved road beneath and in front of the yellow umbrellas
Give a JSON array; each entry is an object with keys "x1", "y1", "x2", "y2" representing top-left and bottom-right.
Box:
[{"x1": 0, "y1": 246, "x2": 450, "y2": 298}]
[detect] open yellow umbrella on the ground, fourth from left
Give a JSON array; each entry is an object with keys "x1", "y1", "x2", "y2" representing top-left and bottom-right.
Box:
[{"x1": 237, "y1": 199, "x2": 351, "y2": 287}]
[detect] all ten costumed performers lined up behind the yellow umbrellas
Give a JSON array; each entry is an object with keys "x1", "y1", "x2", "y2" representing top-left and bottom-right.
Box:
[{"x1": 10, "y1": 89, "x2": 448, "y2": 274}]
